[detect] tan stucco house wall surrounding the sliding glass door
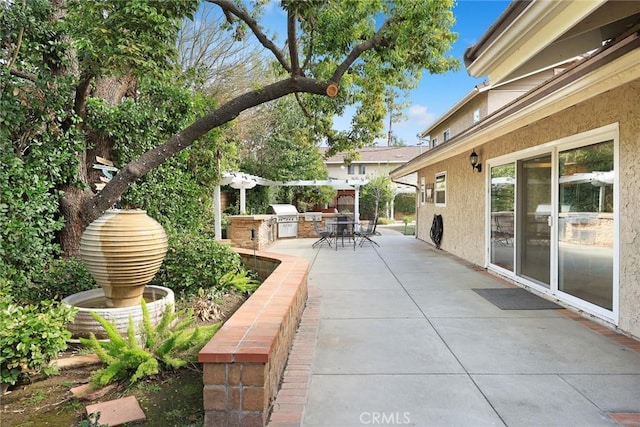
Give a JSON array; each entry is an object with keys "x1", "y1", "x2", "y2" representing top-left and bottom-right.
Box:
[{"x1": 416, "y1": 80, "x2": 640, "y2": 337}]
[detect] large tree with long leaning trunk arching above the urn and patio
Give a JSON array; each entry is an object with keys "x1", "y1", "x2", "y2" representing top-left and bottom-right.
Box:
[{"x1": 2, "y1": 0, "x2": 457, "y2": 255}]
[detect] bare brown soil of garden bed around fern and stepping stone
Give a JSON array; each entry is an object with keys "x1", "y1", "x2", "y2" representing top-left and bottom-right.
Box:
[{"x1": 0, "y1": 292, "x2": 246, "y2": 427}]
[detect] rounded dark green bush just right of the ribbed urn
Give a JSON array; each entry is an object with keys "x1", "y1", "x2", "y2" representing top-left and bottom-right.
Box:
[{"x1": 151, "y1": 233, "x2": 255, "y2": 297}]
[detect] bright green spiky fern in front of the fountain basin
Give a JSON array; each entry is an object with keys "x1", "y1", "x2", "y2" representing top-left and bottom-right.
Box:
[{"x1": 80, "y1": 300, "x2": 222, "y2": 386}]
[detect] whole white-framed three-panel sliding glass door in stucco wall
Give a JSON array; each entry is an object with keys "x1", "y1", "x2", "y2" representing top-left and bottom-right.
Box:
[{"x1": 487, "y1": 126, "x2": 618, "y2": 319}]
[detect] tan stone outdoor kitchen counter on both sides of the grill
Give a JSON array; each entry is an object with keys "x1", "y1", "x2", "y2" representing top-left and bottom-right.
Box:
[{"x1": 227, "y1": 212, "x2": 338, "y2": 250}]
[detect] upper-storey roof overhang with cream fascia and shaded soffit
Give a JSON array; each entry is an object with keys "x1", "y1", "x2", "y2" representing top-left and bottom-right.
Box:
[{"x1": 464, "y1": 0, "x2": 640, "y2": 84}]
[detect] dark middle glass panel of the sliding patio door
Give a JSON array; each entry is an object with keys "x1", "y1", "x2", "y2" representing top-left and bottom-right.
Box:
[{"x1": 517, "y1": 154, "x2": 551, "y2": 288}]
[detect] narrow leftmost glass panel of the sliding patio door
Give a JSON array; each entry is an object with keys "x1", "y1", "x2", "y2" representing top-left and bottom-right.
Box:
[{"x1": 491, "y1": 163, "x2": 516, "y2": 271}]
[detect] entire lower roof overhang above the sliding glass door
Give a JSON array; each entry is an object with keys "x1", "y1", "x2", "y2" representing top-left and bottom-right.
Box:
[{"x1": 390, "y1": 27, "x2": 640, "y2": 180}]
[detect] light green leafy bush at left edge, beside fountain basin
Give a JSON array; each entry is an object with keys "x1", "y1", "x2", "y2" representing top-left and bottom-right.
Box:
[{"x1": 0, "y1": 288, "x2": 76, "y2": 384}]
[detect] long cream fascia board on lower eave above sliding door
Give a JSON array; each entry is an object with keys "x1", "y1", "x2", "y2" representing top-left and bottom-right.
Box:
[{"x1": 389, "y1": 44, "x2": 640, "y2": 180}]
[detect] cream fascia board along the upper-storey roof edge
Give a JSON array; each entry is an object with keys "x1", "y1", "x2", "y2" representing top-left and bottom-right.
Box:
[{"x1": 467, "y1": 0, "x2": 607, "y2": 84}]
